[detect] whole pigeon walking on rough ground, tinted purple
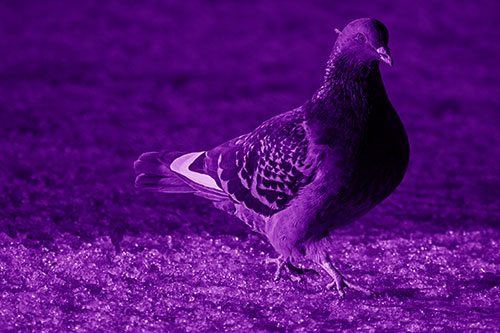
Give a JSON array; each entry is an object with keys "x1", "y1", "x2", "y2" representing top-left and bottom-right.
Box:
[{"x1": 134, "y1": 18, "x2": 409, "y2": 298}]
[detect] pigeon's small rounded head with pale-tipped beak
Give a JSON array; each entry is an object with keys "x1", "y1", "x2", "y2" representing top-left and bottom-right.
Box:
[{"x1": 333, "y1": 18, "x2": 393, "y2": 67}]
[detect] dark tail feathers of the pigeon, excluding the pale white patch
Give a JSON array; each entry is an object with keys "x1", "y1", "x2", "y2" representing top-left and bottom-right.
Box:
[{"x1": 134, "y1": 152, "x2": 196, "y2": 193}]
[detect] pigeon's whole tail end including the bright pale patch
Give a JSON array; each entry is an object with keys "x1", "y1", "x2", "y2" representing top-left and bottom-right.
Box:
[{"x1": 134, "y1": 151, "x2": 227, "y2": 201}]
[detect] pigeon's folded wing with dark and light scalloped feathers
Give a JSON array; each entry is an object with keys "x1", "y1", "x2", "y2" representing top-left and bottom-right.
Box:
[{"x1": 204, "y1": 109, "x2": 312, "y2": 216}]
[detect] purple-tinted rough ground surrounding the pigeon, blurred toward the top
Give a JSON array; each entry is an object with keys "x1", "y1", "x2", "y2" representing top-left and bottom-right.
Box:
[{"x1": 0, "y1": 0, "x2": 500, "y2": 332}]
